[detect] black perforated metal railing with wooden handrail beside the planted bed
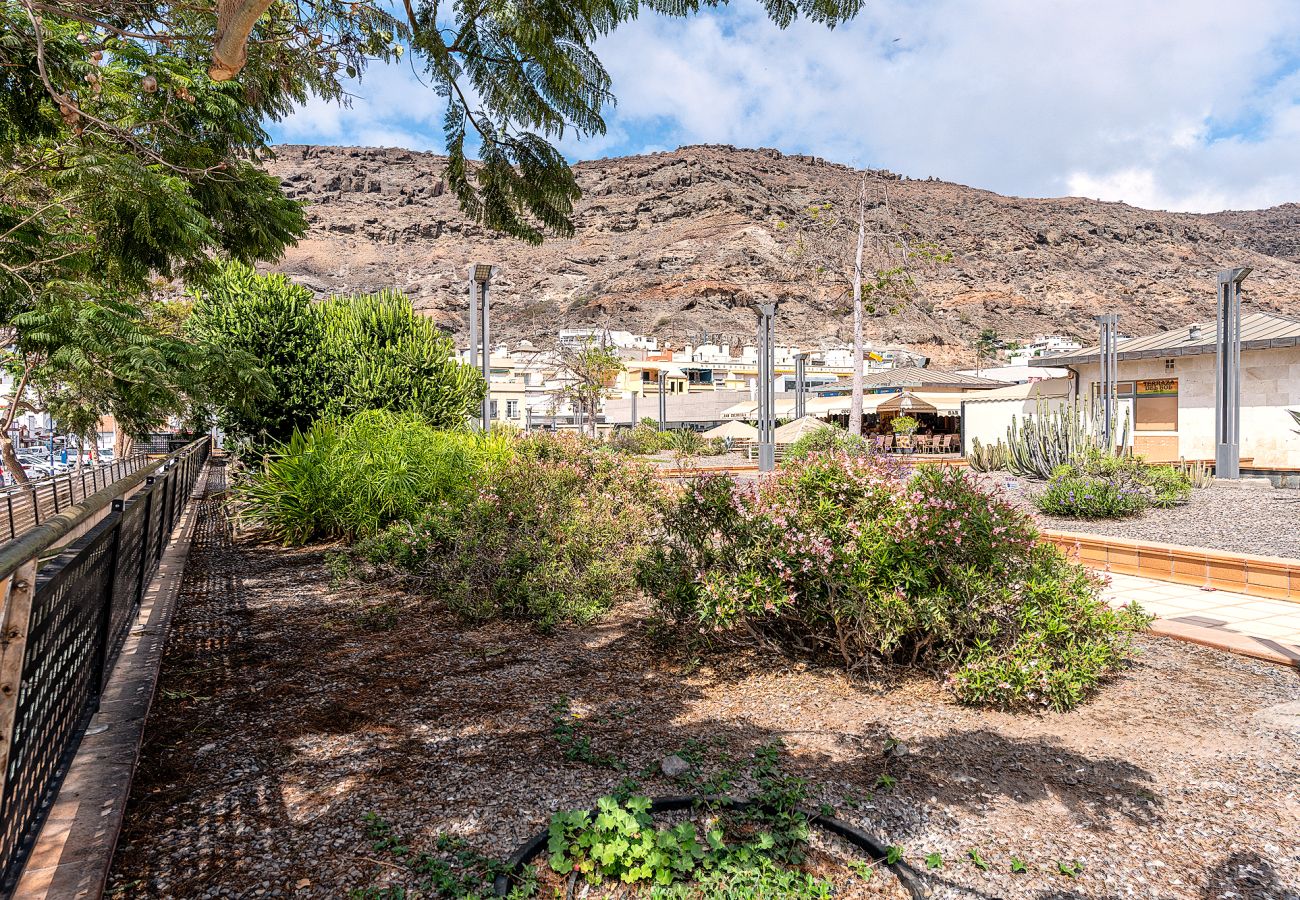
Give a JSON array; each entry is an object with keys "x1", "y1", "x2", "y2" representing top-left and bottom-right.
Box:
[{"x1": 0, "y1": 437, "x2": 209, "y2": 896}]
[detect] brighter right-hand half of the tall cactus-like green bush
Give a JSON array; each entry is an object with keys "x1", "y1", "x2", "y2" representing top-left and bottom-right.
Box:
[{"x1": 320, "y1": 290, "x2": 484, "y2": 428}]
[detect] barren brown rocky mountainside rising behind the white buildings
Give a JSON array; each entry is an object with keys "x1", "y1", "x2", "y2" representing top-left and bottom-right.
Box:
[{"x1": 258, "y1": 146, "x2": 1300, "y2": 362}]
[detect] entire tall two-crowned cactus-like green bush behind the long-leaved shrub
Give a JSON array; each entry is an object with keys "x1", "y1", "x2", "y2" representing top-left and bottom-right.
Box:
[{"x1": 189, "y1": 263, "x2": 484, "y2": 441}]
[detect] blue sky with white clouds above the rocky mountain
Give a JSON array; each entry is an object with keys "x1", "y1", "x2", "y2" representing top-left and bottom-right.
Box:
[{"x1": 263, "y1": 0, "x2": 1300, "y2": 211}]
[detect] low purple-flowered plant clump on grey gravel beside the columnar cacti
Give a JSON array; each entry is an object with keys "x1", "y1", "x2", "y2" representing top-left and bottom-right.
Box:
[{"x1": 1032, "y1": 449, "x2": 1192, "y2": 519}]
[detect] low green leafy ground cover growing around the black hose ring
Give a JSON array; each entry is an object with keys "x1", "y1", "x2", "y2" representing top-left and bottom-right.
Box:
[{"x1": 351, "y1": 743, "x2": 904, "y2": 900}]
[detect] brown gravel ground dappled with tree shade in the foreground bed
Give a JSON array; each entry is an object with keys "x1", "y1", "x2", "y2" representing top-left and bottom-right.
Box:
[{"x1": 109, "y1": 473, "x2": 1300, "y2": 900}]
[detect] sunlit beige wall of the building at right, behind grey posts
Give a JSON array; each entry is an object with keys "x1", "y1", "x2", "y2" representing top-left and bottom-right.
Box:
[{"x1": 1071, "y1": 347, "x2": 1300, "y2": 468}]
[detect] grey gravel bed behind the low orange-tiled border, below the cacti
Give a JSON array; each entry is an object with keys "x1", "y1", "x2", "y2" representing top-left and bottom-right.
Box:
[{"x1": 980, "y1": 472, "x2": 1300, "y2": 559}]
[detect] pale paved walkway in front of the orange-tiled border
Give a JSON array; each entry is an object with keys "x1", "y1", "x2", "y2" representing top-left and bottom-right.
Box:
[{"x1": 1106, "y1": 574, "x2": 1300, "y2": 667}]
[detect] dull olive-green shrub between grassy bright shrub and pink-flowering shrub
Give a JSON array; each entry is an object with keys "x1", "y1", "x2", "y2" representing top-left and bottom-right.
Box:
[{"x1": 358, "y1": 437, "x2": 657, "y2": 628}]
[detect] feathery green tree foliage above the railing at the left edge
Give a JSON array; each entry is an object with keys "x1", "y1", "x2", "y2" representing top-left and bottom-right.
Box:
[{"x1": 0, "y1": 0, "x2": 309, "y2": 479}]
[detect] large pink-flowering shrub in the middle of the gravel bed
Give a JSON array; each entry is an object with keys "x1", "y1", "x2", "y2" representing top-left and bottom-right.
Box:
[{"x1": 640, "y1": 454, "x2": 1147, "y2": 709}]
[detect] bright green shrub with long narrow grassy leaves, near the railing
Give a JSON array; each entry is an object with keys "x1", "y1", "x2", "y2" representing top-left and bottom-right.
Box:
[{"x1": 235, "y1": 410, "x2": 512, "y2": 546}]
